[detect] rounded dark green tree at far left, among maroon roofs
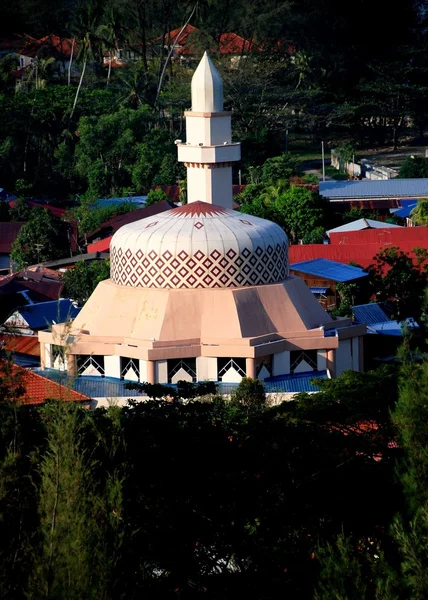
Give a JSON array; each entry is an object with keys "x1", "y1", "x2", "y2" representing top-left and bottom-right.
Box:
[{"x1": 10, "y1": 208, "x2": 69, "y2": 269}]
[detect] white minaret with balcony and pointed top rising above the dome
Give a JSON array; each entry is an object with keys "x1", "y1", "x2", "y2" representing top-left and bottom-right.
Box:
[{"x1": 177, "y1": 52, "x2": 241, "y2": 208}]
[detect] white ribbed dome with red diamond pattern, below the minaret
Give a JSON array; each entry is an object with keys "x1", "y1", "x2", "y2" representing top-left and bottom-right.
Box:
[{"x1": 110, "y1": 202, "x2": 288, "y2": 288}]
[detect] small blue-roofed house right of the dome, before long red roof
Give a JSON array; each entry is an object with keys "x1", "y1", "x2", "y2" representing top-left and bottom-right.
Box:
[{"x1": 290, "y1": 258, "x2": 367, "y2": 310}]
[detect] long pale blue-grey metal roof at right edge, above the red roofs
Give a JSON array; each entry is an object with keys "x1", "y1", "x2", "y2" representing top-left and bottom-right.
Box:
[{"x1": 319, "y1": 178, "x2": 428, "y2": 200}]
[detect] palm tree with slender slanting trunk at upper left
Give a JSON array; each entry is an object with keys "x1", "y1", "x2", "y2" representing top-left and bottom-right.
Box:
[{"x1": 70, "y1": 0, "x2": 103, "y2": 120}]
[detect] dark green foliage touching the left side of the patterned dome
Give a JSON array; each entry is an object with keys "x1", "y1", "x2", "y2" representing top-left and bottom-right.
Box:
[{"x1": 62, "y1": 260, "x2": 110, "y2": 306}]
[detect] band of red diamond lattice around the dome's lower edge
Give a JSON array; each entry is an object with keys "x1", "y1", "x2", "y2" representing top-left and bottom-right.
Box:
[{"x1": 110, "y1": 242, "x2": 288, "y2": 289}]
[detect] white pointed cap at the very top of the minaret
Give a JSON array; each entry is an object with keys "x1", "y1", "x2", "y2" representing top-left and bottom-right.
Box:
[{"x1": 192, "y1": 52, "x2": 223, "y2": 112}]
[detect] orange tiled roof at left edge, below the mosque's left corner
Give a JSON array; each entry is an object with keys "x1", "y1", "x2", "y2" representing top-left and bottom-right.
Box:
[{"x1": 0, "y1": 361, "x2": 89, "y2": 405}]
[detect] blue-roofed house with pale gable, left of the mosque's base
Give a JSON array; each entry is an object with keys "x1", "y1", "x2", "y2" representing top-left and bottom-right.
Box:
[{"x1": 3, "y1": 298, "x2": 80, "y2": 335}]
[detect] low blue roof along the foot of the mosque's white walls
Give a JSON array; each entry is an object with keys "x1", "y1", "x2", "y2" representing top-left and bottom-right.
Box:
[{"x1": 35, "y1": 369, "x2": 327, "y2": 398}]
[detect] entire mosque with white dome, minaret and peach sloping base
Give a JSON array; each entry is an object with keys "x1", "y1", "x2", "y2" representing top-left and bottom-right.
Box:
[{"x1": 39, "y1": 53, "x2": 365, "y2": 383}]
